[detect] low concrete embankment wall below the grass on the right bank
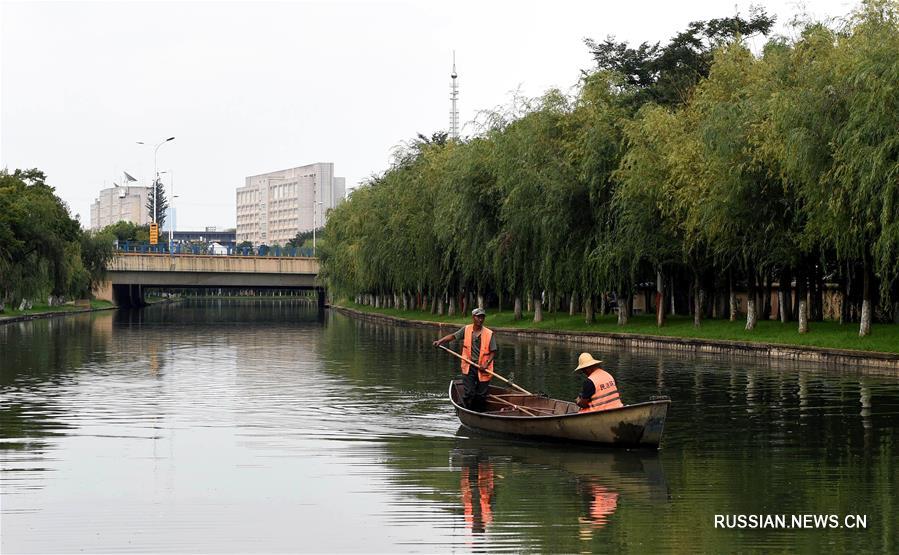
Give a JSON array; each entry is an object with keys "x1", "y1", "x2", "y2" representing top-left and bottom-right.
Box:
[{"x1": 331, "y1": 306, "x2": 899, "y2": 376}]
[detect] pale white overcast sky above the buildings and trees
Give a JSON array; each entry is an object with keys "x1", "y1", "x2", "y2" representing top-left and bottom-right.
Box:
[{"x1": 0, "y1": 0, "x2": 857, "y2": 229}]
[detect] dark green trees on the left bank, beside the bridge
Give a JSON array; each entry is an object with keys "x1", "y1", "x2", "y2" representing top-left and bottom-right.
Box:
[{"x1": 0, "y1": 169, "x2": 112, "y2": 311}]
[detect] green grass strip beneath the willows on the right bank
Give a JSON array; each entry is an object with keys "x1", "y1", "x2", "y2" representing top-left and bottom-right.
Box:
[{"x1": 339, "y1": 301, "x2": 899, "y2": 353}]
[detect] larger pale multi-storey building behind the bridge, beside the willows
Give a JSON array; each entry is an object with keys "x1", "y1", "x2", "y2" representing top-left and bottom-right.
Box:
[{"x1": 237, "y1": 162, "x2": 346, "y2": 245}]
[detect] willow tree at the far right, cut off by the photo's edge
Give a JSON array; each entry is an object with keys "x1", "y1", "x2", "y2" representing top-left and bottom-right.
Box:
[{"x1": 828, "y1": 0, "x2": 899, "y2": 336}]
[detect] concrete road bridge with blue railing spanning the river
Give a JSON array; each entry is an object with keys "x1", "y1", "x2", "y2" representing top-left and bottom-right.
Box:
[{"x1": 94, "y1": 252, "x2": 324, "y2": 307}]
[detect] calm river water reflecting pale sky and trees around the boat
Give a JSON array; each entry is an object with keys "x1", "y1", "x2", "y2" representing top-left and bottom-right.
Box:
[{"x1": 0, "y1": 300, "x2": 899, "y2": 553}]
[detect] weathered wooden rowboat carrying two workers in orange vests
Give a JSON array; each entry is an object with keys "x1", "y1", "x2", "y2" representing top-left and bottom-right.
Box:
[{"x1": 449, "y1": 379, "x2": 671, "y2": 449}]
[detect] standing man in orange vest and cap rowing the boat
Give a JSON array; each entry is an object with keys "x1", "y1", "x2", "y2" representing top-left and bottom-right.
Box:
[{"x1": 434, "y1": 308, "x2": 497, "y2": 412}]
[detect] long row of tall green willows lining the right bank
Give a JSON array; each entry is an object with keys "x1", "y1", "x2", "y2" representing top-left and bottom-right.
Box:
[{"x1": 320, "y1": 0, "x2": 899, "y2": 335}]
